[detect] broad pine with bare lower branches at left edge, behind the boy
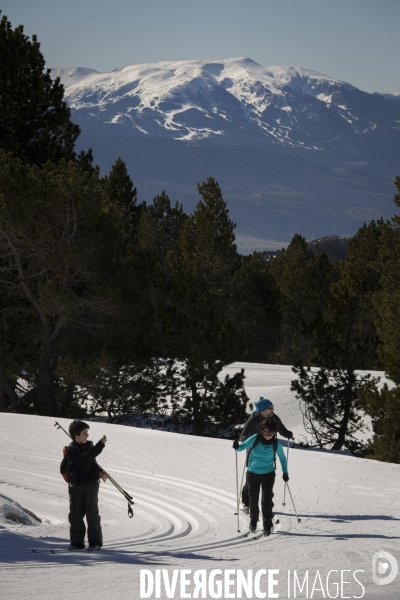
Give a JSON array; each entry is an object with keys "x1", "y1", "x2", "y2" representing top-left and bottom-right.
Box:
[{"x1": 0, "y1": 152, "x2": 134, "y2": 414}]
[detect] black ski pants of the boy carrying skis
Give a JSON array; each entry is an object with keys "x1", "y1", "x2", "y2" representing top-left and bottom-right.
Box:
[{"x1": 68, "y1": 481, "x2": 103, "y2": 546}]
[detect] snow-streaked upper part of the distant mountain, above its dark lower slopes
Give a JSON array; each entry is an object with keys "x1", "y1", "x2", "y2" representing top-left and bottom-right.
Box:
[{"x1": 52, "y1": 58, "x2": 400, "y2": 149}]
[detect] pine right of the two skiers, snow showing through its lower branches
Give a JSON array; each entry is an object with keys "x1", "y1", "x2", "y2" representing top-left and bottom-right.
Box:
[{"x1": 292, "y1": 222, "x2": 385, "y2": 453}]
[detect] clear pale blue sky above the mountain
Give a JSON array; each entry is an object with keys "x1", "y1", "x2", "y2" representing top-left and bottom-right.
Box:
[{"x1": 0, "y1": 0, "x2": 400, "y2": 92}]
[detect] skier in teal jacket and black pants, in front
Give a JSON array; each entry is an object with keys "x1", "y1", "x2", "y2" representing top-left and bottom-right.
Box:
[{"x1": 233, "y1": 419, "x2": 289, "y2": 535}]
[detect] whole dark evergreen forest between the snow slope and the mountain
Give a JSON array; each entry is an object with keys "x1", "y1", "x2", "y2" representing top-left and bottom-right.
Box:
[{"x1": 0, "y1": 16, "x2": 400, "y2": 463}]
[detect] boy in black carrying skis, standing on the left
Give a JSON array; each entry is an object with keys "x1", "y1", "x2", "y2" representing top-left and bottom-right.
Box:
[{"x1": 67, "y1": 420, "x2": 107, "y2": 550}]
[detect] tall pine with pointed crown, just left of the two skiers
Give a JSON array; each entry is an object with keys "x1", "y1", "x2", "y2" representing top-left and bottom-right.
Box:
[{"x1": 153, "y1": 178, "x2": 247, "y2": 435}]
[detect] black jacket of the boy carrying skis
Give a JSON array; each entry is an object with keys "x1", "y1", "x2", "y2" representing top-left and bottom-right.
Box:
[{"x1": 67, "y1": 440, "x2": 104, "y2": 485}]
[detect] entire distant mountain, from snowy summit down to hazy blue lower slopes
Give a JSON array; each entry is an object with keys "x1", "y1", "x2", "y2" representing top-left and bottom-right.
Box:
[{"x1": 52, "y1": 58, "x2": 400, "y2": 253}]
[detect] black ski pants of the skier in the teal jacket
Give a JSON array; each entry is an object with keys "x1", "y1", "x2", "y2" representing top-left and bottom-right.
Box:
[{"x1": 246, "y1": 471, "x2": 275, "y2": 529}]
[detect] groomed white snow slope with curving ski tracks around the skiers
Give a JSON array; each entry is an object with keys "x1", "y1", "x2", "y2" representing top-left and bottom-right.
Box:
[{"x1": 0, "y1": 365, "x2": 400, "y2": 600}]
